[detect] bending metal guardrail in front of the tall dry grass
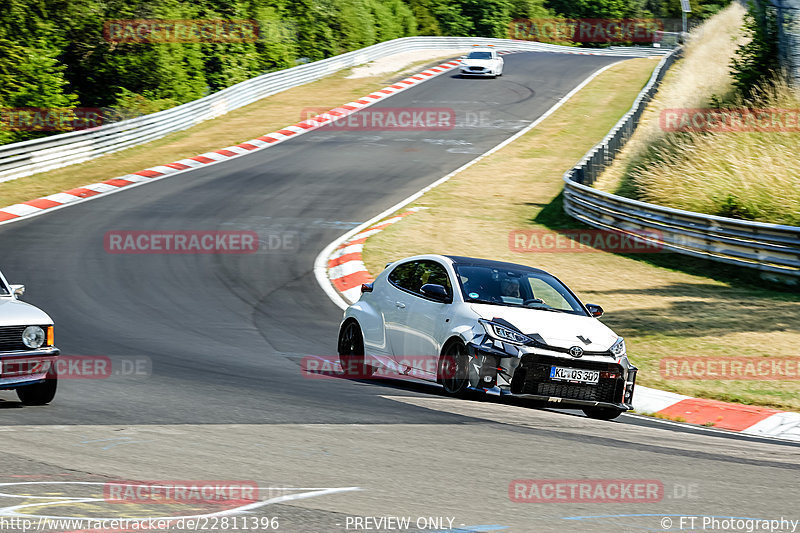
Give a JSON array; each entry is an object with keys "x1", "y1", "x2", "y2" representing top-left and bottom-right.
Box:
[{"x1": 564, "y1": 49, "x2": 800, "y2": 282}]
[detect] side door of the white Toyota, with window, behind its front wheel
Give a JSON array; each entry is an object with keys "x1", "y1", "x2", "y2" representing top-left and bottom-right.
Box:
[{"x1": 403, "y1": 260, "x2": 453, "y2": 378}]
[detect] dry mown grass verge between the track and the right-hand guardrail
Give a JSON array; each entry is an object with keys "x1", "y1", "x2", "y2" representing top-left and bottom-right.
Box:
[{"x1": 364, "y1": 55, "x2": 800, "y2": 410}]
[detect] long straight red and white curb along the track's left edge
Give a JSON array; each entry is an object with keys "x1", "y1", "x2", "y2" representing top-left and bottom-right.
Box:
[{"x1": 0, "y1": 60, "x2": 468, "y2": 224}]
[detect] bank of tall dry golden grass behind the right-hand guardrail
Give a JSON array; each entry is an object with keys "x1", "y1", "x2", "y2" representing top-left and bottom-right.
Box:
[{"x1": 597, "y1": 3, "x2": 800, "y2": 225}]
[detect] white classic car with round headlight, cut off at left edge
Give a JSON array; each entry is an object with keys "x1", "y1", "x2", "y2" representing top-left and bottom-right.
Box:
[{"x1": 0, "y1": 273, "x2": 59, "y2": 405}]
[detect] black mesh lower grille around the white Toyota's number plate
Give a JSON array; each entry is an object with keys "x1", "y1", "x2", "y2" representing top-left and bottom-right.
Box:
[{"x1": 511, "y1": 356, "x2": 625, "y2": 403}]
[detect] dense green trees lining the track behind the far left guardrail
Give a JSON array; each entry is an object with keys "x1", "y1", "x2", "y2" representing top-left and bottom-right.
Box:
[{"x1": 0, "y1": 0, "x2": 727, "y2": 142}]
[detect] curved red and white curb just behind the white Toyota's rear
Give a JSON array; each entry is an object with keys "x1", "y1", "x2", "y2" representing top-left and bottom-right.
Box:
[{"x1": 328, "y1": 207, "x2": 425, "y2": 303}]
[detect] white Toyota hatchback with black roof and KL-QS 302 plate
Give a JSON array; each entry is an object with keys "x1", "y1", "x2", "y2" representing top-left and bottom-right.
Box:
[{"x1": 338, "y1": 255, "x2": 636, "y2": 420}]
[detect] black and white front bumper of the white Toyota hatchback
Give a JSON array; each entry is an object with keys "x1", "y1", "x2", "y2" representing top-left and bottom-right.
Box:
[{"x1": 467, "y1": 343, "x2": 637, "y2": 411}]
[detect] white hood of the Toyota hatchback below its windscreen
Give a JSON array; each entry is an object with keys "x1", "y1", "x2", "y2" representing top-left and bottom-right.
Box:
[{"x1": 471, "y1": 304, "x2": 617, "y2": 352}]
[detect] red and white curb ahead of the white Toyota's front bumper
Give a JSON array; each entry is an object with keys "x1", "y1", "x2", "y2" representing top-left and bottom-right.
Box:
[{"x1": 633, "y1": 385, "x2": 800, "y2": 442}]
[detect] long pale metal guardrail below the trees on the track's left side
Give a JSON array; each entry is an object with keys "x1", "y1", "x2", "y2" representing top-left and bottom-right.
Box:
[{"x1": 0, "y1": 37, "x2": 667, "y2": 181}]
